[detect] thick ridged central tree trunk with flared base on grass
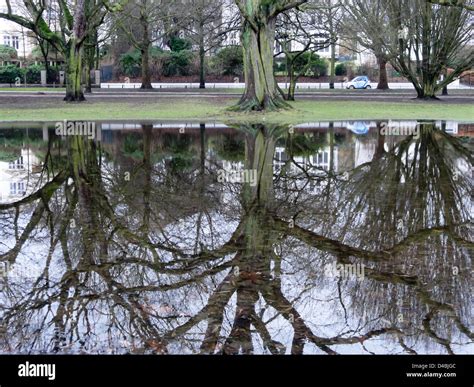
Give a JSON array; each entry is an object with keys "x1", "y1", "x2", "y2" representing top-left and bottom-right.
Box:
[{"x1": 231, "y1": 15, "x2": 290, "y2": 111}]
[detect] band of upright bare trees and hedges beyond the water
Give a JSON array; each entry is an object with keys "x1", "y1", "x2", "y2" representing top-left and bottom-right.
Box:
[{"x1": 0, "y1": 0, "x2": 474, "y2": 110}]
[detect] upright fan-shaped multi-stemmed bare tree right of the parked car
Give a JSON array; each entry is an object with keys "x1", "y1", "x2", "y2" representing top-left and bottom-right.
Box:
[{"x1": 382, "y1": 0, "x2": 474, "y2": 98}]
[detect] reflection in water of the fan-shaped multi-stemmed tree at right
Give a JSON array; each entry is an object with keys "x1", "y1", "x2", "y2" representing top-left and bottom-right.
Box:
[{"x1": 334, "y1": 123, "x2": 472, "y2": 352}]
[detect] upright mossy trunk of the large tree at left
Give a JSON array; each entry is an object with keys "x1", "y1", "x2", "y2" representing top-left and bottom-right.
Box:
[{"x1": 64, "y1": 40, "x2": 85, "y2": 102}]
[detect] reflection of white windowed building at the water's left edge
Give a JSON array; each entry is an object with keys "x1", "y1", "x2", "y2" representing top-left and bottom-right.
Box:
[{"x1": 0, "y1": 149, "x2": 41, "y2": 203}]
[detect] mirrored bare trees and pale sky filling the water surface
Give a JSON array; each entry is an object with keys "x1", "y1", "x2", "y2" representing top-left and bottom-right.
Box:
[{"x1": 0, "y1": 125, "x2": 473, "y2": 354}]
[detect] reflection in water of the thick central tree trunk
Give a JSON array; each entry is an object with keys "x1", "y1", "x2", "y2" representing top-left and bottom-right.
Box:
[{"x1": 223, "y1": 128, "x2": 282, "y2": 354}]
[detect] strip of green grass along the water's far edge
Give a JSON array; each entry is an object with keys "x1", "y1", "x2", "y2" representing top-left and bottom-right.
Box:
[{"x1": 0, "y1": 98, "x2": 474, "y2": 123}]
